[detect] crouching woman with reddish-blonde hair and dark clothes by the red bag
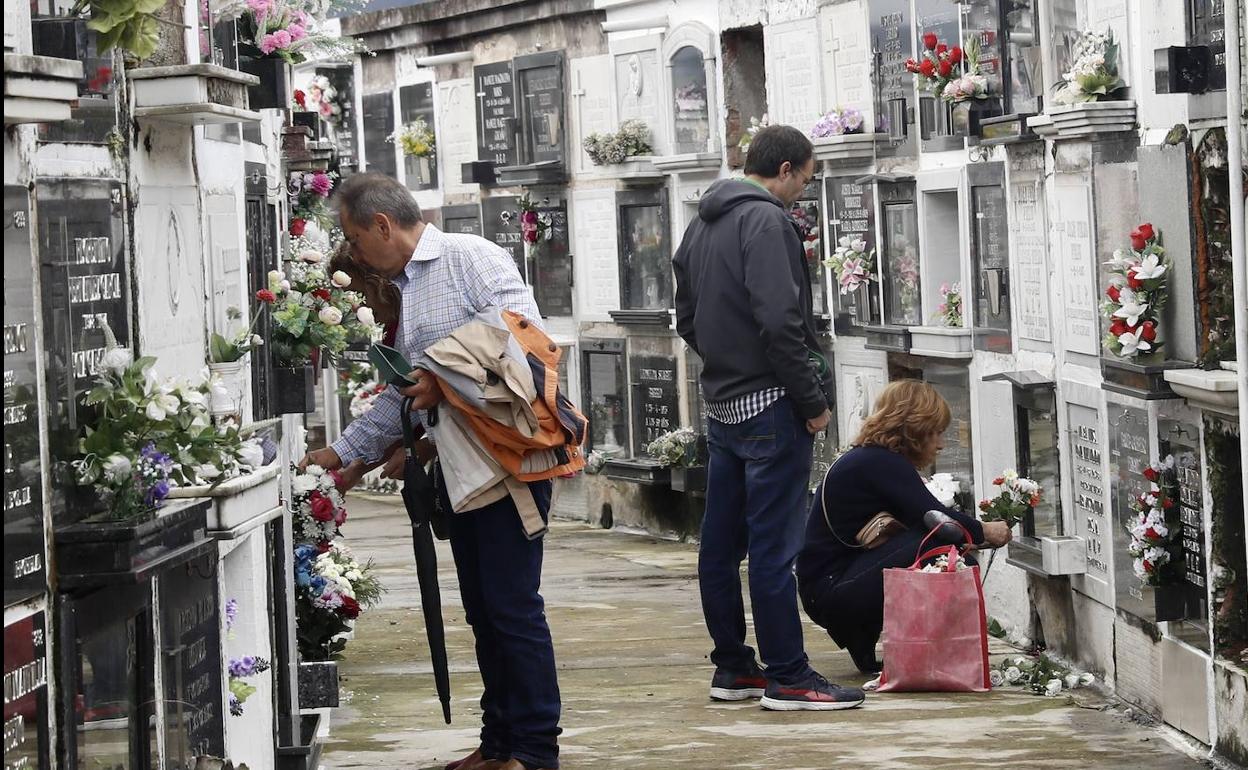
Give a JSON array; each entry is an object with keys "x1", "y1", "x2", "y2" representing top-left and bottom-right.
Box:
[{"x1": 797, "y1": 379, "x2": 1010, "y2": 674}]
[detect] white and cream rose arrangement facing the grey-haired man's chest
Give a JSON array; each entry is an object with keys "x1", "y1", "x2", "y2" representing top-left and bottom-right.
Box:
[{"x1": 256, "y1": 250, "x2": 382, "y2": 367}]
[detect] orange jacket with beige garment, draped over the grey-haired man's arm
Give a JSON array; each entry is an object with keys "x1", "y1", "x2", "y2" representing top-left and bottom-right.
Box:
[{"x1": 437, "y1": 311, "x2": 589, "y2": 482}]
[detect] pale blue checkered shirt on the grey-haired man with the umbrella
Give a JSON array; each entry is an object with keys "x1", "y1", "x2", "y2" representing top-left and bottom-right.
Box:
[{"x1": 333, "y1": 225, "x2": 542, "y2": 465}]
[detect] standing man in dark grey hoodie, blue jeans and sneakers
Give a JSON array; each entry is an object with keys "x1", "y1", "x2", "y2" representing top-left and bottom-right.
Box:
[{"x1": 673, "y1": 126, "x2": 864, "y2": 710}]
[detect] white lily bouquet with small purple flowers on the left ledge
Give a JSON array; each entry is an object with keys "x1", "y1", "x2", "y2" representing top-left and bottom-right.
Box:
[{"x1": 74, "y1": 346, "x2": 263, "y2": 519}]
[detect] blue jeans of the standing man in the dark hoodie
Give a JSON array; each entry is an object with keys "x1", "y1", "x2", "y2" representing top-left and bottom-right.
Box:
[{"x1": 698, "y1": 398, "x2": 814, "y2": 685}]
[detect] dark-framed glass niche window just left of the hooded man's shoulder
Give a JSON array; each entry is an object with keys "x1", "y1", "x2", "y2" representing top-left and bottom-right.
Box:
[{"x1": 617, "y1": 191, "x2": 675, "y2": 311}]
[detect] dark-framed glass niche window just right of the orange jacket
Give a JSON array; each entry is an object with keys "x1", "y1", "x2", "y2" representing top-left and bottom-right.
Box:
[{"x1": 580, "y1": 339, "x2": 629, "y2": 457}]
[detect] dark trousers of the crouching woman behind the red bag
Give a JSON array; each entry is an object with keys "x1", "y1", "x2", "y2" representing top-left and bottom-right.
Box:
[{"x1": 800, "y1": 529, "x2": 975, "y2": 648}]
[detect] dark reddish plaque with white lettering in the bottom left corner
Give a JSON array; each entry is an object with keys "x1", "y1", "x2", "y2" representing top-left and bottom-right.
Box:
[{"x1": 4, "y1": 612, "x2": 50, "y2": 770}]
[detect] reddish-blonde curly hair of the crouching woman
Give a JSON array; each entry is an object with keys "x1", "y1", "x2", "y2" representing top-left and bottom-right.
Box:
[{"x1": 854, "y1": 379, "x2": 952, "y2": 464}]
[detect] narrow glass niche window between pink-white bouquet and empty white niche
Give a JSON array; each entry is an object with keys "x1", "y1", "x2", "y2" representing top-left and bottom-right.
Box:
[{"x1": 880, "y1": 183, "x2": 924, "y2": 326}]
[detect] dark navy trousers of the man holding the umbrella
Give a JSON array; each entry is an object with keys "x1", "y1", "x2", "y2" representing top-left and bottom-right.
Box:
[{"x1": 441, "y1": 482, "x2": 560, "y2": 768}]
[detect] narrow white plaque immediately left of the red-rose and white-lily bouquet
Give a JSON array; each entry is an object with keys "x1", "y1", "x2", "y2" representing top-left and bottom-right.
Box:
[{"x1": 1053, "y1": 181, "x2": 1101, "y2": 356}]
